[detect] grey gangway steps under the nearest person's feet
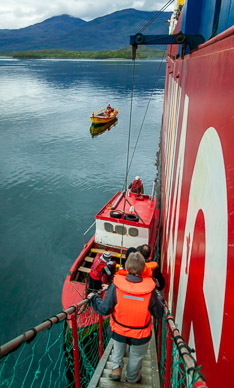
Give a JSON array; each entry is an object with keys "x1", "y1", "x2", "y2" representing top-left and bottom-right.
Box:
[{"x1": 87, "y1": 328, "x2": 160, "y2": 388}]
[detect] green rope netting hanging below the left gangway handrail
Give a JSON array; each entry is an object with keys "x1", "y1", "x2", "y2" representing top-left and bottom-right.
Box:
[{"x1": 0, "y1": 305, "x2": 109, "y2": 388}]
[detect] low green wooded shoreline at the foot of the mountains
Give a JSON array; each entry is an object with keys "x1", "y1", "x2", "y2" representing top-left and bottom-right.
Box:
[{"x1": 0, "y1": 46, "x2": 163, "y2": 59}]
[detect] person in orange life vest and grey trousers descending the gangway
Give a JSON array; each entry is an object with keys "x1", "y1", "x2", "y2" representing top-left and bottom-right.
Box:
[{"x1": 88, "y1": 252, "x2": 164, "y2": 383}]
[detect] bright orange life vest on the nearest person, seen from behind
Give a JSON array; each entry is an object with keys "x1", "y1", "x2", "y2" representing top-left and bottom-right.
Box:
[{"x1": 110, "y1": 274, "x2": 155, "y2": 339}]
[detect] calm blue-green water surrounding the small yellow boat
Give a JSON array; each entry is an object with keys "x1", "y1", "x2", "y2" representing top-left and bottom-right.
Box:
[{"x1": 0, "y1": 60, "x2": 165, "y2": 343}]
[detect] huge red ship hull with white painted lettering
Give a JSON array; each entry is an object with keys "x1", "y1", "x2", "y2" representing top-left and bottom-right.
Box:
[{"x1": 162, "y1": 28, "x2": 234, "y2": 388}]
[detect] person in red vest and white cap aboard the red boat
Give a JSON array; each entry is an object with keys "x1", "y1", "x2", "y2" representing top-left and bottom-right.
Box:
[{"x1": 88, "y1": 252, "x2": 116, "y2": 291}]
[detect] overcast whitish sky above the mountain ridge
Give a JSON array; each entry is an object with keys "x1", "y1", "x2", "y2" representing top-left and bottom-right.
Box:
[{"x1": 0, "y1": 0, "x2": 176, "y2": 29}]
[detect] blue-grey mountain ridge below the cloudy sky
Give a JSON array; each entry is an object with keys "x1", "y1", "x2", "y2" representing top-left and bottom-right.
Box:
[{"x1": 0, "y1": 8, "x2": 171, "y2": 52}]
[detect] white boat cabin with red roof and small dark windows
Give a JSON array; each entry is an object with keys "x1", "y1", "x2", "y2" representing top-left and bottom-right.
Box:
[{"x1": 95, "y1": 191, "x2": 158, "y2": 249}]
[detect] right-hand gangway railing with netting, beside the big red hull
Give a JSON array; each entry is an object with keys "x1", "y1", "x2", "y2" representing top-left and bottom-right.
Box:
[{"x1": 155, "y1": 307, "x2": 208, "y2": 388}]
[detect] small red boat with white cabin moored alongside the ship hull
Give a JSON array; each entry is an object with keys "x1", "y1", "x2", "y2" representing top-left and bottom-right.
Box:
[{"x1": 62, "y1": 186, "x2": 159, "y2": 314}]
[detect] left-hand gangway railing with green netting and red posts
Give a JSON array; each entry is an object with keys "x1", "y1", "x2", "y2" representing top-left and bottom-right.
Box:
[{"x1": 0, "y1": 299, "x2": 110, "y2": 388}]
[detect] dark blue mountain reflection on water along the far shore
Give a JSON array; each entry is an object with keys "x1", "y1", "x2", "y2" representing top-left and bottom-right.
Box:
[{"x1": 0, "y1": 59, "x2": 166, "y2": 96}]
